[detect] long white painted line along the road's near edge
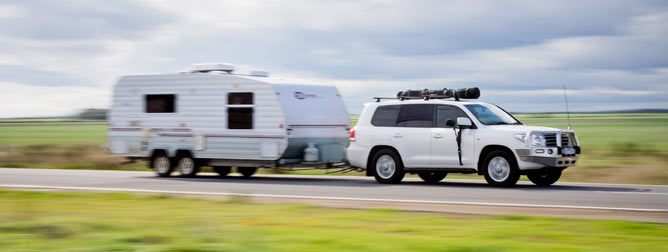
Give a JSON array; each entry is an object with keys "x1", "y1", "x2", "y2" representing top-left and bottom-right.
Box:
[{"x1": 0, "y1": 184, "x2": 668, "y2": 213}]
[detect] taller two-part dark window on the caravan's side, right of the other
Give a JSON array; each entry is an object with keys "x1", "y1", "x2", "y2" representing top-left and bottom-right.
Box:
[{"x1": 227, "y1": 92, "x2": 253, "y2": 129}]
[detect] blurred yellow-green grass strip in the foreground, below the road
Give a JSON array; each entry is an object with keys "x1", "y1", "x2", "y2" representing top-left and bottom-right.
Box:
[{"x1": 0, "y1": 191, "x2": 668, "y2": 252}]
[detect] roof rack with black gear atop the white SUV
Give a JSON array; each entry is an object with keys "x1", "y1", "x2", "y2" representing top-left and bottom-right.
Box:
[{"x1": 374, "y1": 87, "x2": 480, "y2": 102}]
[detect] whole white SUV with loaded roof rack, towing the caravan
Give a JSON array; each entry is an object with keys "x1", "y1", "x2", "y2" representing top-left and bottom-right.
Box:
[{"x1": 347, "y1": 89, "x2": 580, "y2": 186}]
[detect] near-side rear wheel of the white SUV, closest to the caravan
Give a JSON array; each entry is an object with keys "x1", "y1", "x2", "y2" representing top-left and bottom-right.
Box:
[{"x1": 371, "y1": 149, "x2": 406, "y2": 184}]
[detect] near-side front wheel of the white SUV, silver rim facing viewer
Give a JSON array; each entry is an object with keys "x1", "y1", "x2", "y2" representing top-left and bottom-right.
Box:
[{"x1": 482, "y1": 150, "x2": 520, "y2": 187}]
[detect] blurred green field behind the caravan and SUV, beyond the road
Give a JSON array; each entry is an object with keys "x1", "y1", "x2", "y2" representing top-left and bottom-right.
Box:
[{"x1": 0, "y1": 114, "x2": 668, "y2": 184}]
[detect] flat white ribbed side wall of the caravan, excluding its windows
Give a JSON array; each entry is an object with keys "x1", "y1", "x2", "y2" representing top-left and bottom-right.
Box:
[{"x1": 109, "y1": 74, "x2": 287, "y2": 160}]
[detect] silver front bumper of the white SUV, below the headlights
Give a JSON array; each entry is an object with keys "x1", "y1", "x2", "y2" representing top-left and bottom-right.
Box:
[{"x1": 515, "y1": 146, "x2": 580, "y2": 167}]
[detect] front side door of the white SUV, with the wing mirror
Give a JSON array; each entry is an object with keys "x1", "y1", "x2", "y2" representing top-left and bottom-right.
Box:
[{"x1": 431, "y1": 105, "x2": 475, "y2": 168}]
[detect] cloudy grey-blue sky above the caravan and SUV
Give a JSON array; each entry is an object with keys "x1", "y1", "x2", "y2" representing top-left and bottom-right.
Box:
[{"x1": 0, "y1": 0, "x2": 668, "y2": 117}]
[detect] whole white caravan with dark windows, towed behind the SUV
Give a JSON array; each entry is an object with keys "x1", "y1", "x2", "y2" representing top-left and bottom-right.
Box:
[{"x1": 108, "y1": 63, "x2": 350, "y2": 176}]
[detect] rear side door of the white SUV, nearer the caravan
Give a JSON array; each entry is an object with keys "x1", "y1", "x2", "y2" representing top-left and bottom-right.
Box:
[{"x1": 390, "y1": 104, "x2": 434, "y2": 168}]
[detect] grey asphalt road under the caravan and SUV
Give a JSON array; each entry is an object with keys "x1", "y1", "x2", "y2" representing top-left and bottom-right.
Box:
[{"x1": 0, "y1": 168, "x2": 668, "y2": 222}]
